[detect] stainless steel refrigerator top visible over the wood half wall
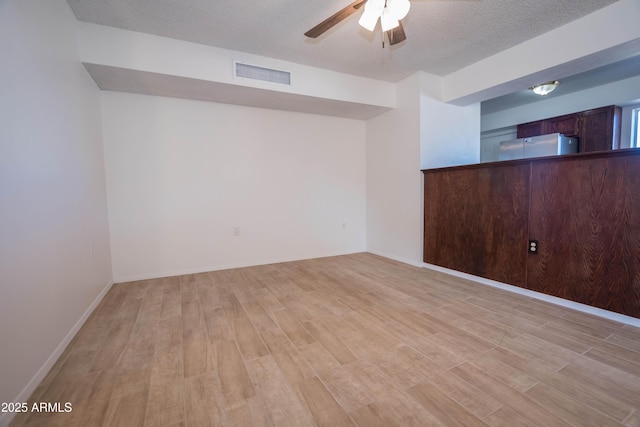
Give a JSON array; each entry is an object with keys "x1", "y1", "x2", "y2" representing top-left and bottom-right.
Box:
[{"x1": 498, "y1": 133, "x2": 578, "y2": 160}]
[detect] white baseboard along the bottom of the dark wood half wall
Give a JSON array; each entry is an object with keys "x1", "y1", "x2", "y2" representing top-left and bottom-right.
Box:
[{"x1": 422, "y1": 263, "x2": 640, "y2": 327}]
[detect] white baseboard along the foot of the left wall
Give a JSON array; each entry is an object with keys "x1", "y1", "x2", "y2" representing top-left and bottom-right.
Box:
[{"x1": 0, "y1": 282, "x2": 113, "y2": 427}]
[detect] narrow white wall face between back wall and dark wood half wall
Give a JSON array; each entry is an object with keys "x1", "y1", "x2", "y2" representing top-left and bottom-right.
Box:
[{"x1": 367, "y1": 73, "x2": 422, "y2": 264}]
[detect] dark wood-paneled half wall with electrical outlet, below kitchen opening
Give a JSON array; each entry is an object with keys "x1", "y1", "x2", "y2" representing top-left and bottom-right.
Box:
[{"x1": 423, "y1": 149, "x2": 640, "y2": 318}]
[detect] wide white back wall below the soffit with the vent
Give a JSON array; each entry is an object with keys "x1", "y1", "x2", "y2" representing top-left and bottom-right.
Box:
[{"x1": 102, "y1": 92, "x2": 365, "y2": 282}]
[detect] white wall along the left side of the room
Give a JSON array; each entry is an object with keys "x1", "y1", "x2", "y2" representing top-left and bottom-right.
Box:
[{"x1": 0, "y1": 0, "x2": 111, "y2": 425}]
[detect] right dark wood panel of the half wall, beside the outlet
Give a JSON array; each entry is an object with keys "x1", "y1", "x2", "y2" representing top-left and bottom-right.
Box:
[{"x1": 527, "y1": 155, "x2": 640, "y2": 317}]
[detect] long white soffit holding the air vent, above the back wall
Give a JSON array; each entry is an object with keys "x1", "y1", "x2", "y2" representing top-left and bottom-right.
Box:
[{"x1": 77, "y1": 23, "x2": 395, "y2": 119}]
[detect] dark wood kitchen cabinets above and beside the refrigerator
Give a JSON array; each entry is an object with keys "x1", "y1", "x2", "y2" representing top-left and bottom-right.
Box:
[{"x1": 517, "y1": 105, "x2": 622, "y2": 153}]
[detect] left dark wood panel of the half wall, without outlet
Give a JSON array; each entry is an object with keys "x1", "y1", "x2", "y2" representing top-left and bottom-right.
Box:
[{"x1": 424, "y1": 162, "x2": 530, "y2": 286}]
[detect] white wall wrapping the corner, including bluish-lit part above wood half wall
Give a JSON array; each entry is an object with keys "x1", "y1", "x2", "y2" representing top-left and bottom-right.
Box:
[{"x1": 367, "y1": 72, "x2": 480, "y2": 265}]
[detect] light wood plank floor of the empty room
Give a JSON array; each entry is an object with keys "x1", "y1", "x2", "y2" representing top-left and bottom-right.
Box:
[{"x1": 12, "y1": 254, "x2": 640, "y2": 427}]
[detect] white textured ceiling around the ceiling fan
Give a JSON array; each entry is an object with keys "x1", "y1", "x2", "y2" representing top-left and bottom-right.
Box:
[{"x1": 67, "y1": 0, "x2": 615, "y2": 82}]
